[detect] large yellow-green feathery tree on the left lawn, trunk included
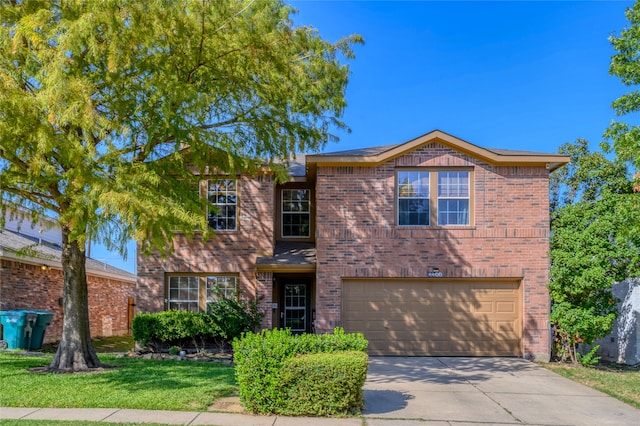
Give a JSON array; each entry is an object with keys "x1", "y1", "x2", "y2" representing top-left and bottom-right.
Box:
[{"x1": 0, "y1": 0, "x2": 361, "y2": 371}]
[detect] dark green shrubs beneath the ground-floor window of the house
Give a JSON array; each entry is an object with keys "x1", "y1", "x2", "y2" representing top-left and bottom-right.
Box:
[{"x1": 132, "y1": 297, "x2": 263, "y2": 352}]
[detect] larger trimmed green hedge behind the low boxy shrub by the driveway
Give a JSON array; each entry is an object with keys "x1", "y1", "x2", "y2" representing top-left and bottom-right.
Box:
[{"x1": 233, "y1": 328, "x2": 368, "y2": 415}]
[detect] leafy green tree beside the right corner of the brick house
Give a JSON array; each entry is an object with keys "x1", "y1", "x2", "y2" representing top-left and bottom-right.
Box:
[{"x1": 549, "y1": 140, "x2": 640, "y2": 362}]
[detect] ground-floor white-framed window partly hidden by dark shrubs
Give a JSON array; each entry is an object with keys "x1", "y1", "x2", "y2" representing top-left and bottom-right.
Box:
[{"x1": 167, "y1": 274, "x2": 238, "y2": 312}]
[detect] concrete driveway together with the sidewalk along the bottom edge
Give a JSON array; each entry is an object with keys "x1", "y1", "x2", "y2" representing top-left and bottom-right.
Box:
[{"x1": 0, "y1": 357, "x2": 640, "y2": 426}]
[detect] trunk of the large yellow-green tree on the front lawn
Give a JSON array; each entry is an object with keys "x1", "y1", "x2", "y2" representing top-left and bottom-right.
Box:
[{"x1": 48, "y1": 226, "x2": 102, "y2": 373}]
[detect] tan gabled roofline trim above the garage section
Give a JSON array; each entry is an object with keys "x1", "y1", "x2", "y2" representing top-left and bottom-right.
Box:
[{"x1": 306, "y1": 130, "x2": 571, "y2": 171}]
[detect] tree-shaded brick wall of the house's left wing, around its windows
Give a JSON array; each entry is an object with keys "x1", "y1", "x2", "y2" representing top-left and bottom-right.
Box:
[{"x1": 137, "y1": 175, "x2": 274, "y2": 327}]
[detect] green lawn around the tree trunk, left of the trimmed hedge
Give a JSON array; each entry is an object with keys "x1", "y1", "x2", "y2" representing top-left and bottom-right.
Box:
[{"x1": 0, "y1": 352, "x2": 237, "y2": 411}]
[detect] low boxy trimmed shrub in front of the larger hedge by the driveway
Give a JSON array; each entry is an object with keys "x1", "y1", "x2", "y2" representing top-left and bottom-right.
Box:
[{"x1": 277, "y1": 351, "x2": 368, "y2": 416}]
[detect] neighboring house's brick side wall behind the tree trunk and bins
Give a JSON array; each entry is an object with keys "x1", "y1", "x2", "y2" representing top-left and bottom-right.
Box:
[{"x1": 0, "y1": 259, "x2": 136, "y2": 342}]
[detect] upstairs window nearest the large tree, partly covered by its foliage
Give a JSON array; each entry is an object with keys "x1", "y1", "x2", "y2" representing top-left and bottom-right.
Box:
[{"x1": 207, "y1": 179, "x2": 238, "y2": 231}]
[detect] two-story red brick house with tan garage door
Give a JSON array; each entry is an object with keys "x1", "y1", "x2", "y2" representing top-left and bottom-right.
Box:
[{"x1": 137, "y1": 130, "x2": 569, "y2": 360}]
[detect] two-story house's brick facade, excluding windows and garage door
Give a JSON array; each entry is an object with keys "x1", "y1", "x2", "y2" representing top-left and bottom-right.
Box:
[{"x1": 137, "y1": 131, "x2": 568, "y2": 360}]
